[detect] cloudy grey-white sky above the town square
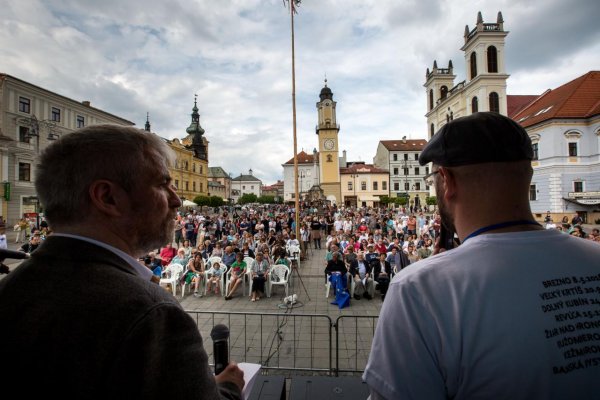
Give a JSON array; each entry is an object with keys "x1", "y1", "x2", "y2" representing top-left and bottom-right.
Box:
[{"x1": 0, "y1": 0, "x2": 600, "y2": 184}]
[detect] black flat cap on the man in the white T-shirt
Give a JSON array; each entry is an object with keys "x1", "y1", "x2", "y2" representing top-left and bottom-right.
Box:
[{"x1": 419, "y1": 112, "x2": 533, "y2": 167}]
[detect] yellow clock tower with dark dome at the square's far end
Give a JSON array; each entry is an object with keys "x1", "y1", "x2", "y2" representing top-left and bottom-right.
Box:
[{"x1": 316, "y1": 79, "x2": 342, "y2": 204}]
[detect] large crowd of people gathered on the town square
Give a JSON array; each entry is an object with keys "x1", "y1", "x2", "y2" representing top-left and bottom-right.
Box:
[{"x1": 136, "y1": 206, "x2": 600, "y2": 301}]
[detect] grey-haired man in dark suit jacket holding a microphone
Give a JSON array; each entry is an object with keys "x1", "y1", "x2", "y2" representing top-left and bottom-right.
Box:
[{"x1": 0, "y1": 125, "x2": 244, "y2": 400}]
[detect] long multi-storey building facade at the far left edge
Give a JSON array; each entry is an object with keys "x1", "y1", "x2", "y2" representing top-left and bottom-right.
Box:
[{"x1": 0, "y1": 73, "x2": 134, "y2": 226}]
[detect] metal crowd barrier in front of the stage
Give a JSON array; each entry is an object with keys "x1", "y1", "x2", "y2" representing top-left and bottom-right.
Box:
[{"x1": 187, "y1": 311, "x2": 378, "y2": 376}]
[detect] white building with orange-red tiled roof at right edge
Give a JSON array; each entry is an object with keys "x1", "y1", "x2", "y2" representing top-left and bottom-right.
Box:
[{"x1": 511, "y1": 71, "x2": 600, "y2": 223}]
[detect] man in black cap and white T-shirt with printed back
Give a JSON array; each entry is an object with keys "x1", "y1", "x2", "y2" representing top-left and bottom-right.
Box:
[{"x1": 363, "y1": 113, "x2": 600, "y2": 400}]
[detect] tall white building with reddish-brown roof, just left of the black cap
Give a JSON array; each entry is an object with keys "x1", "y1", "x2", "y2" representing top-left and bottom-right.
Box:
[{"x1": 373, "y1": 137, "x2": 429, "y2": 206}]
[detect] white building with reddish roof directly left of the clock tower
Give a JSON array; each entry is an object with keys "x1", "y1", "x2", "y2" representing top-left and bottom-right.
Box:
[{"x1": 282, "y1": 149, "x2": 319, "y2": 202}]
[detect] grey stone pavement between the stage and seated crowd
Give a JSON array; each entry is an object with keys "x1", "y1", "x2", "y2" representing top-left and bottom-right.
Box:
[{"x1": 177, "y1": 250, "x2": 382, "y2": 373}]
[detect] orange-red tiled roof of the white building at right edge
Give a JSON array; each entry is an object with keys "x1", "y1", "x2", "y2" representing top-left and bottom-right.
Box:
[{"x1": 513, "y1": 71, "x2": 600, "y2": 128}]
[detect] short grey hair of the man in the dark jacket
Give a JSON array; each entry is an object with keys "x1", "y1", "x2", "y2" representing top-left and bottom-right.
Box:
[{"x1": 35, "y1": 125, "x2": 175, "y2": 224}]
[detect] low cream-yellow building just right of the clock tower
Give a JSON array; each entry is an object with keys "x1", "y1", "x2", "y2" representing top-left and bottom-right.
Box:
[{"x1": 340, "y1": 163, "x2": 390, "y2": 207}]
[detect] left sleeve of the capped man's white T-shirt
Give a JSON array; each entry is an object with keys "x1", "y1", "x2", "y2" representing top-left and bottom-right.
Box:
[{"x1": 363, "y1": 282, "x2": 447, "y2": 400}]
